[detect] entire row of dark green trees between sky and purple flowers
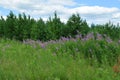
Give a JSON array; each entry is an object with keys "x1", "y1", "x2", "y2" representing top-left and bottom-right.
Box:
[{"x1": 0, "y1": 11, "x2": 120, "y2": 41}]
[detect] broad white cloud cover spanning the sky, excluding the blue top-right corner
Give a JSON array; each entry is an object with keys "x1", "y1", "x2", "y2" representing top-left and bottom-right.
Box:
[{"x1": 0, "y1": 0, "x2": 120, "y2": 23}]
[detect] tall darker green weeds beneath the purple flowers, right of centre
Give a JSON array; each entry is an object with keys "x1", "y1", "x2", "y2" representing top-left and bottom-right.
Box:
[{"x1": 50, "y1": 40, "x2": 120, "y2": 65}]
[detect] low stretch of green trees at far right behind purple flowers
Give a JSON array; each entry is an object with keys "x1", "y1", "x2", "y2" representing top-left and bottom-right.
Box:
[{"x1": 91, "y1": 22, "x2": 120, "y2": 40}]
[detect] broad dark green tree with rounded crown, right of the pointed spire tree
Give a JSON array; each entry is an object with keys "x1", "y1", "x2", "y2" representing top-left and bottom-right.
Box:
[{"x1": 67, "y1": 14, "x2": 89, "y2": 36}]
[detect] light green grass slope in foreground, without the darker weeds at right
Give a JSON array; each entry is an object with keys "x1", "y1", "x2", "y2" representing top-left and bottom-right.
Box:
[{"x1": 0, "y1": 40, "x2": 120, "y2": 80}]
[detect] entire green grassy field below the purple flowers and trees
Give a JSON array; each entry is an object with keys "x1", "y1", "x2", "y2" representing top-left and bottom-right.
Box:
[{"x1": 0, "y1": 39, "x2": 120, "y2": 80}]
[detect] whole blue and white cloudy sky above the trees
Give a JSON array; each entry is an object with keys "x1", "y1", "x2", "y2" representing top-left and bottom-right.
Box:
[{"x1": 0, "y1": 0, "x2": 120, "y2": 24}]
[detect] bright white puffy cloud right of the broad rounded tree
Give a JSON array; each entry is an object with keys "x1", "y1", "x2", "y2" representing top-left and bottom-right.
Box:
[{"x1": 71, "y1": 6, "x2": 120, "y2": 24}]
